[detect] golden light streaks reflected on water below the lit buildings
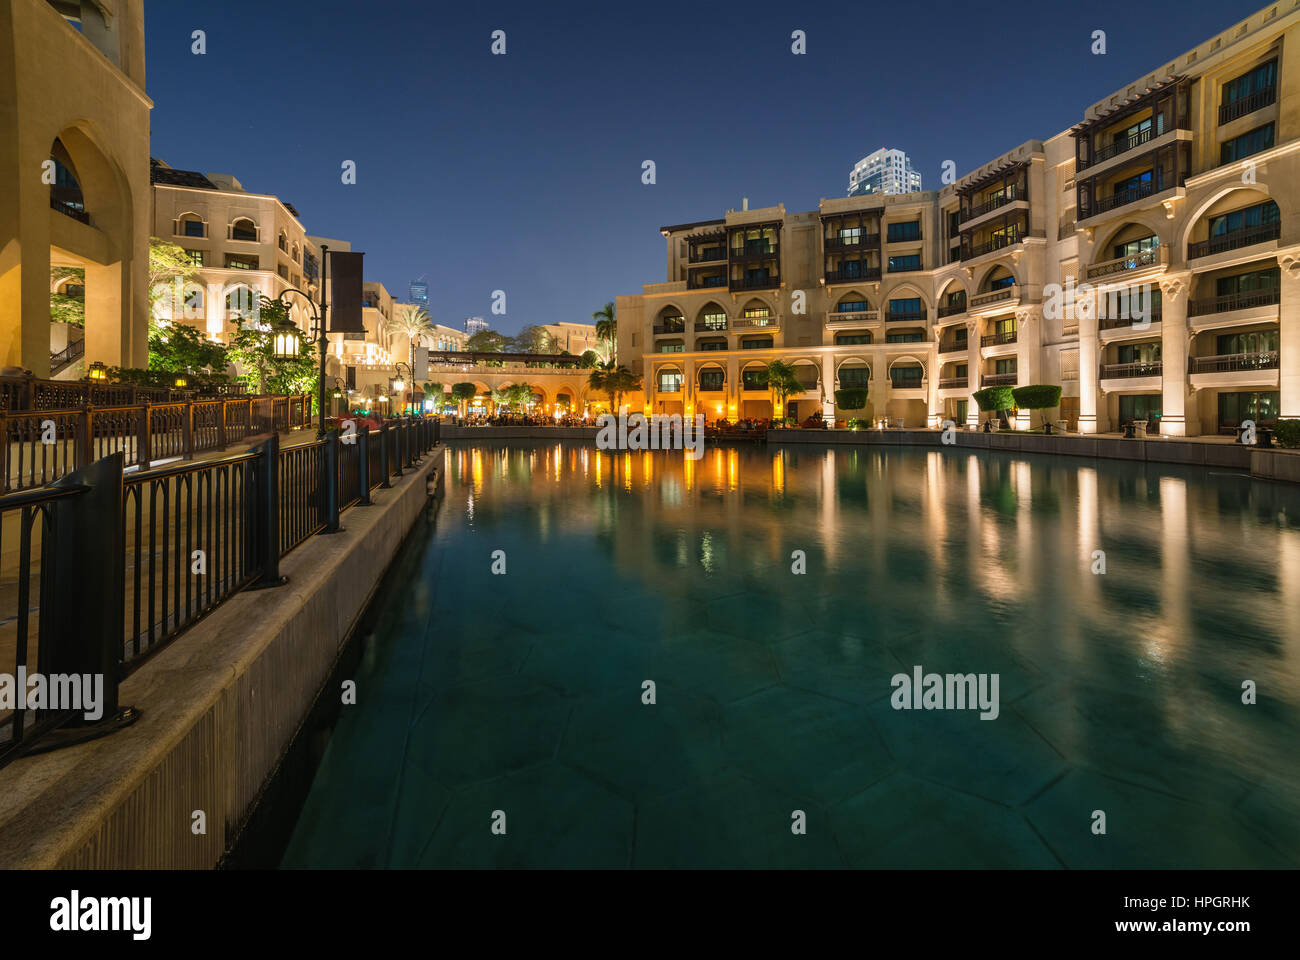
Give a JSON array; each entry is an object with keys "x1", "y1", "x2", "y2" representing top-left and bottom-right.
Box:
[{"x1": 447, "y1": 445, "x2": 1300, "y2": 697}]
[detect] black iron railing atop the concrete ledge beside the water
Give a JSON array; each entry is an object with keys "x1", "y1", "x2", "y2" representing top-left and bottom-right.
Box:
[{"x1": 0, "y1": 418, "x2": 439, "y2": 765}]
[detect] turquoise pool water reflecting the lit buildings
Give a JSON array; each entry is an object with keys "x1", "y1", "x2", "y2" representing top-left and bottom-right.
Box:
[{"x1": 283, "y1": 442, "x2": 1300, "y2": 868}]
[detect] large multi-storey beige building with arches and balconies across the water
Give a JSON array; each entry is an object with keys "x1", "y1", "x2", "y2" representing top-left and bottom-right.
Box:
[{"x1": 618, "y1": 0, "x2": 1300, "y2": 436}]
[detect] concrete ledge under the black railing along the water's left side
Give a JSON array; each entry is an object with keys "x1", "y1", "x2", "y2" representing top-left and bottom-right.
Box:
[{"x1": 0, "y1": 447, "x2": 443, "y2": 869}]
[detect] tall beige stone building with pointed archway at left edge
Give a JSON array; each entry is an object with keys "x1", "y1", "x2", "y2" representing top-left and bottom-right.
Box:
[{"x1": 0, "y1": 0, "x2": 152, "y2": 376}]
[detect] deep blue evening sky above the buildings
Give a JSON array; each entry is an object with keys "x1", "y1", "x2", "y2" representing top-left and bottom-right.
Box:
[{"x1": 146, "y1": 0, "x2": 1264, "y2": 333}]
